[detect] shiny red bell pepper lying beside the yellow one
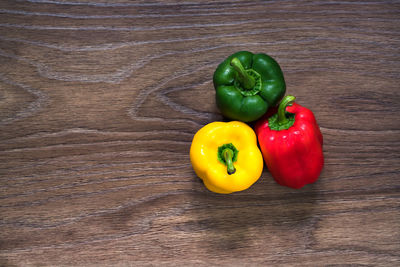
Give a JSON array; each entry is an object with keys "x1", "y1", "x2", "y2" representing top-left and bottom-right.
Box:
[{"x1": 255, "y1": 96, "x2": 324, "y2": 188}]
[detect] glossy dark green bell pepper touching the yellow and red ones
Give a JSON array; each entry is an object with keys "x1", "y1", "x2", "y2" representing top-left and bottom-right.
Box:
[{"x1": 213, "y1": 51, "x2": 286, "y2": 122}]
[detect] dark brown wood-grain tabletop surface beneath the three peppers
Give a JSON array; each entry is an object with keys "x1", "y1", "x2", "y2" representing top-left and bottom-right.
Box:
[{"x1": 0, "y1": 0, "x2": 400, "y2": 266}]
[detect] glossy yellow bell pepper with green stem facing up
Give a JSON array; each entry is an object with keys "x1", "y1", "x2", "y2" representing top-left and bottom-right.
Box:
[{"x1": 190, "y1": 121, "x2": 264, "y2": 194}]
